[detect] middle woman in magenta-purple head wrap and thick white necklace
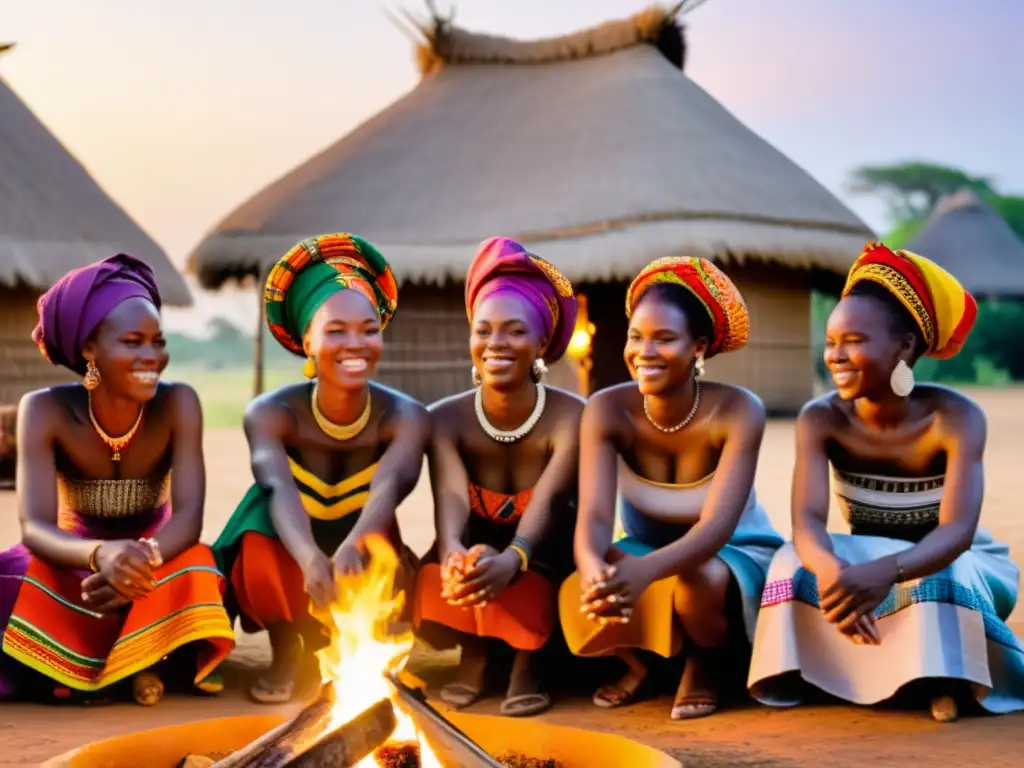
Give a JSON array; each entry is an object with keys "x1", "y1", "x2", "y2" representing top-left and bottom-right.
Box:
[{"x1": 415, "y1": 238, "x2": 583, "y2": 717}]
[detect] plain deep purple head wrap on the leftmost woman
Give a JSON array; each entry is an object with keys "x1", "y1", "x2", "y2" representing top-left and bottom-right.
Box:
[{"x1": 32, "y1": 253, "x2": 161, "y2": 375}]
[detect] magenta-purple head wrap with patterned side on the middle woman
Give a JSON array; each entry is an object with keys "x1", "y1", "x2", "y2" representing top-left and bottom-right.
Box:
[{"x1": 466, "y1": 238, "x2": 577, "y2": 362}]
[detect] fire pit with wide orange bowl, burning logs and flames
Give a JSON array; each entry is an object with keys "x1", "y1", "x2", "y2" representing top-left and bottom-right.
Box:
[{"x1": 41, "y1": 537, "x2": 681, "y2": 768}]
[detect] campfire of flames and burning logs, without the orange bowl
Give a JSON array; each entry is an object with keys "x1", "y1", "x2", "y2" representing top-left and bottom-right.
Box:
[{"x1": 194, "y1": 536, "x2": 540, "y2": 768}]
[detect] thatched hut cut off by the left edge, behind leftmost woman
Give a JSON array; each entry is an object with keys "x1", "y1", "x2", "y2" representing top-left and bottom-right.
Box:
[{"x1": 0, "y1": 45, "x2": 191, "y2": 407}]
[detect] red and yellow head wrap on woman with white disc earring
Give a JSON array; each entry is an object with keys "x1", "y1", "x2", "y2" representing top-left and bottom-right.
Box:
[{"x1": 843, "y1": 243, "x2": 978, "y2": 359}]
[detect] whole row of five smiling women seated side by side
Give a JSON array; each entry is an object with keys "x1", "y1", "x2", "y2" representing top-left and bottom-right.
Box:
[{"x1": 0, "y1": 233, "x2": 1024, "y2": 720}]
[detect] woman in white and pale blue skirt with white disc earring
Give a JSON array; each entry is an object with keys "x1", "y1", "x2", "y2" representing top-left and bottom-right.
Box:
[{"x1": 750, "y1": 243, "x2": 1024, "y2": 721}]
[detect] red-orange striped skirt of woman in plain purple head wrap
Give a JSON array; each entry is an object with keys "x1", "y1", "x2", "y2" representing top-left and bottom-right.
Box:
[{"x1": 0, "y1": 509, "x2": 234, "y2": 692}]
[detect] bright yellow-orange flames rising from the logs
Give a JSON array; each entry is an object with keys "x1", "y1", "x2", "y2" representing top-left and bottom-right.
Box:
[{"x1": 314, "y1": 534, "x2": 441, "y2": 768}]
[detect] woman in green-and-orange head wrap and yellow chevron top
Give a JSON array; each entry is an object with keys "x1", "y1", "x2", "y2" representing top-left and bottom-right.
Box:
[{"x1": 213, "y1": 233, "x2": 430, "y2": 703}]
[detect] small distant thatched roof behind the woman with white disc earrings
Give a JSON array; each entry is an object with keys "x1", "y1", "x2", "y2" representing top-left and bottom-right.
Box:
[{"x1": 906, "y1": 188, "x2": 1024, "y2": 298}]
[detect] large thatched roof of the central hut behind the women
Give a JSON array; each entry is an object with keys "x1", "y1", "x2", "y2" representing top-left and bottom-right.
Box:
[{"x1": 189, "y1": 3, "x2": 872, "y2": 288}]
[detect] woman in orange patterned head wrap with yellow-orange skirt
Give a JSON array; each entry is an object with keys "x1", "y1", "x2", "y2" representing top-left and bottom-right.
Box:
[{"x1": 559, "y1": 258, "x2": 782, "y2": 719}]
